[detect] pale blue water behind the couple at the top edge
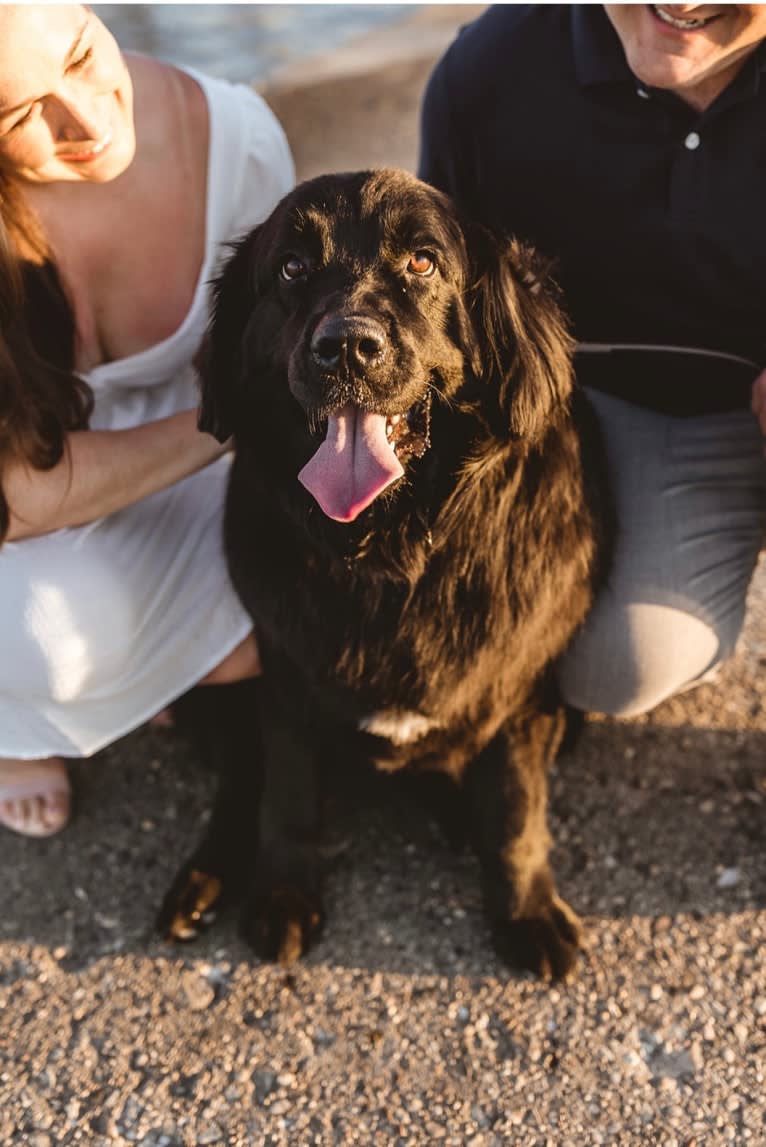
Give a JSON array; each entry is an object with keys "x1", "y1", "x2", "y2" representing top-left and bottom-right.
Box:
[{"x1": 94, "y1": 3, "x2": 422, "y2": 84}]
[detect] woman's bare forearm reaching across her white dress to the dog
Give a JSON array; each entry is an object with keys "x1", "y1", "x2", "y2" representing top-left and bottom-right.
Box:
[{"x1": 2, "y1": 411, "x2": 227, "y2": 541}]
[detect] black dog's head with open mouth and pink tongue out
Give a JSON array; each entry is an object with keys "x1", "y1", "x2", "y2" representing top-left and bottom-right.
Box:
[{"x1": 201, "y1": 171, "x2": 571, "y2": 522}]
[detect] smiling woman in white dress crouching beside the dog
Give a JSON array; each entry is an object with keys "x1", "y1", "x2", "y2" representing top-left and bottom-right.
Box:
[{"x1": 0, "y1": 5, "x2": 294, "y2": 835}]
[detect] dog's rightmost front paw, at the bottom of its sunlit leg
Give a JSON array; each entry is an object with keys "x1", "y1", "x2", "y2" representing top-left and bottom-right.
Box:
[{"x1": 494, "y1": 894, "x2": 580, "y2": 980}]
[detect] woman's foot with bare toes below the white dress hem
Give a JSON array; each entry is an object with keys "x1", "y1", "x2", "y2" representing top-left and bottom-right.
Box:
[{"x1": 0, "y1": 757, "x2": 71, "y2": 836}]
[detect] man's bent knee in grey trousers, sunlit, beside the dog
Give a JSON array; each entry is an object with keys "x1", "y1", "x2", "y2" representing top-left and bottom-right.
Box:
[{"x1": 560, "y1": 603, "x2": 738, "y2": 717}]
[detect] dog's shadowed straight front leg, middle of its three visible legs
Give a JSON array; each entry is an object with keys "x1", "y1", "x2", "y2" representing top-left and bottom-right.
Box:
[{"x1": 242, "y1": 682, "x2": 323, "y2": 963}]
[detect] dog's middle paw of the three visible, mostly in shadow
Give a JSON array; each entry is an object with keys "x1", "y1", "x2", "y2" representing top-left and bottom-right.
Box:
[{"x1": 242, "y1": 888, "x2": 325, "y2": 965}]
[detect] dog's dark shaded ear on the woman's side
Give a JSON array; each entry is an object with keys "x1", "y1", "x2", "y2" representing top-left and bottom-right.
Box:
[{"x1": 195, "y1": 227, "x2": 260, "y2": 442}]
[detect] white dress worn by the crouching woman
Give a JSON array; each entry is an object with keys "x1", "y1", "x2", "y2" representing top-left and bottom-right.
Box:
[{"x1": 0, "y1": 72, "x2": 295, "y2": 759}]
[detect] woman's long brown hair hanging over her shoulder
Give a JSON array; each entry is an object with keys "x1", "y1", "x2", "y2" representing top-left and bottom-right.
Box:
[{"x1": 0, "y1": 170, "x2": 93, "y2": 545}]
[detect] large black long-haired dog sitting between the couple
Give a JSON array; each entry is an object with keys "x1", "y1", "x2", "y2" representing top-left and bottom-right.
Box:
[{"x1": 163, "y1": 171, "x2": 608, "y2": 976}]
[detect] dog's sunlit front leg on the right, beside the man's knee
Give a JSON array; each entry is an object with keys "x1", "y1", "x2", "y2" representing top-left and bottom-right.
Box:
[{"x1": 466, "y1": 713, "x2": 579, "y2": 980}]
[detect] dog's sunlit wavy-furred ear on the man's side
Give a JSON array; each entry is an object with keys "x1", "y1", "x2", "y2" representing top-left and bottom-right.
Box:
[{"x1": 469, "y1": 228, "x2": 575, "y2": 442}]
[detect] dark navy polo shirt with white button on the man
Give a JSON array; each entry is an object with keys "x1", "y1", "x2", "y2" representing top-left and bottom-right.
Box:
[{"x1": 420, "y1": 5, "x2": 766, "y2": 365}]
